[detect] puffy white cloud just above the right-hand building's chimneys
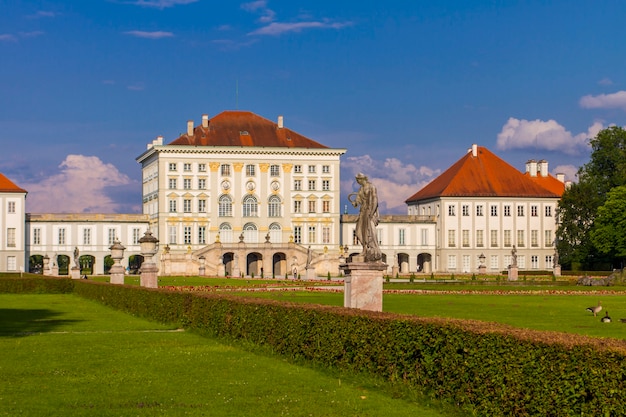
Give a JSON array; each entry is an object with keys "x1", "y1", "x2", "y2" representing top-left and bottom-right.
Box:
[{"x1": 497, "y1": 117, "x2": 603, "y2": 155}]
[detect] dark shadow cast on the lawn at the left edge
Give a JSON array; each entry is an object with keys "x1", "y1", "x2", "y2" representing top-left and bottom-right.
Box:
[{"x1": 0, "y1": 308, "x2": 82, "y2": 337}]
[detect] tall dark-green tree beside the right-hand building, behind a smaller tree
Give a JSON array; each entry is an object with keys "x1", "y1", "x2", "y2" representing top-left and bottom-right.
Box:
[{"x1": 556, "y1": 126, "x2": 626, "y2": 269}]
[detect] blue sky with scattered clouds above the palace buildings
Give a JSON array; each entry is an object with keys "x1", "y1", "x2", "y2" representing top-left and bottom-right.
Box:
[{"x1": 0, "y1": 0, "x2": 626, "y2": 214}]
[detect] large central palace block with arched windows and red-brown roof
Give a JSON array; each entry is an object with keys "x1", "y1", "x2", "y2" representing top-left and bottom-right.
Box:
[{"x1": 137, "y1": 111, "x2": 346, "y2": 277}]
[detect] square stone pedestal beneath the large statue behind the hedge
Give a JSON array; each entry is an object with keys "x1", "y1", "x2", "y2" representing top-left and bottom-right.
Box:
[{"x1": 339, "y1": 257, "x2": 387, "y2": 311}]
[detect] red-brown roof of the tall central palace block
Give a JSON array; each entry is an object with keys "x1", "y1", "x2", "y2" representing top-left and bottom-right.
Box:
[{"x1": 169, "y1": 111, "x2": 328, "y2": 148}]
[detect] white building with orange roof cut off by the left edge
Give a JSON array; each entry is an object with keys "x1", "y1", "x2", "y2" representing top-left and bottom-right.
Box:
[{"x1": 0, "y1": 174, "x2": 27, "y2": 272}]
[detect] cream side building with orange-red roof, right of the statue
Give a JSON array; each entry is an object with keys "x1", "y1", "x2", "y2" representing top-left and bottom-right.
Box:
[{"x1": 406, "y1": 145, "x2": 565, "y2": 273}]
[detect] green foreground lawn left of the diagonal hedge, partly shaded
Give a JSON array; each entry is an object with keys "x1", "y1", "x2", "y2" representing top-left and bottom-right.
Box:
[{"x1": 0, "y1": 294, "x2": 449, "y2": 417}]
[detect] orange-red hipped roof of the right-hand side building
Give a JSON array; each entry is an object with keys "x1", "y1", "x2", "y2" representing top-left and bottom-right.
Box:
[{"x1": 405, "y1": 146, "x2": 565, "y2": 203}]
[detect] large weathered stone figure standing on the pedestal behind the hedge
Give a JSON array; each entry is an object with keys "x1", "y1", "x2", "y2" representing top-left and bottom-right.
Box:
[{"x1": 348, "y1": 173, "x2": 382, "y2": 262}]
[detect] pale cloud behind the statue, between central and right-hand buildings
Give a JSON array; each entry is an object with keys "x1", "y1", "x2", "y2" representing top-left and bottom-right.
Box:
[{"x1": 341, "y1": 155, "x2": 441, "y2": 214}]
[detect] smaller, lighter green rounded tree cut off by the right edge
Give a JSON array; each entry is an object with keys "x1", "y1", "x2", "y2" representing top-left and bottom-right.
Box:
[{"x1": 591, "y1": 185, "x2": 626, "y2": 266}]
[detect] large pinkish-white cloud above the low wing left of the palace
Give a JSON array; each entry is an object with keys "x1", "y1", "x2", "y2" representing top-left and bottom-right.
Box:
[{"x1": 21, "y1": 155, "x2": 132, "y2": 213}]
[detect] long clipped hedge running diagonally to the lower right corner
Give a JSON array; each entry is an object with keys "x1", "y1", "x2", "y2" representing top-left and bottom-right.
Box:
[{"x1": 0, "y1": 281, "x2": 626, "y2": 416}]
